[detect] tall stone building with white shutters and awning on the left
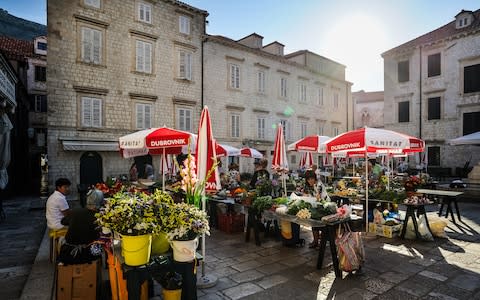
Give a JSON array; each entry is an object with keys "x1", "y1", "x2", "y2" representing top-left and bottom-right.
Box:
[{"x1": 47, "y1": 0, "x2": 207, "y2": 190}]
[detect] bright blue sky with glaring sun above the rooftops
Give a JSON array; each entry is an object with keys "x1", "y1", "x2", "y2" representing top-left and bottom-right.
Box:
[{"x1": 0, "y1": 0, "x2": 480, "y2": 92}]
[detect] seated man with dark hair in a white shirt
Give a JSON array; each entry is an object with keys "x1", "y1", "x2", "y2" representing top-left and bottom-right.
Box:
[{"x1": 45, "y1": 178, "x2": 71, "y2": 230}]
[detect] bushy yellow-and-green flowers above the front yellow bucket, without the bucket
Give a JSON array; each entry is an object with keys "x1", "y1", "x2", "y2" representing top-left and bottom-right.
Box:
[{"x1": 95, "y1": 192, "x2": 160, "y2": 235}]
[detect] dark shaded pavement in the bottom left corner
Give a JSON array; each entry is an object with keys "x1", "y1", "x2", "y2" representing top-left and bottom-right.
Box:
[{"x1": 0, "y1": 197, "x2": 46, "y2": 300}]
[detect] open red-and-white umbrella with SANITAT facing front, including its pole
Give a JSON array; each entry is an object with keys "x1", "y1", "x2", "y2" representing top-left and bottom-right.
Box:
[{"x1": 325, "y1": 127, "x2": 425, "y2": 232}]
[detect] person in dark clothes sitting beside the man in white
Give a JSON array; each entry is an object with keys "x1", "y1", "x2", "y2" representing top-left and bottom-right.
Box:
[{"x1": 58, "y1": 189, "x2": 103, "y2": 264}]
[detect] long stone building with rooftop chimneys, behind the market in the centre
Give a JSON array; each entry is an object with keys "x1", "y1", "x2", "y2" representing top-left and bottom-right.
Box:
[{"x1": 204, "y1": 33, "x2": 353, "y2": 171}]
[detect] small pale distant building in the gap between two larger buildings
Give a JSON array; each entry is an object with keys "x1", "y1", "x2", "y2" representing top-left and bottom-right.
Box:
[{"x1": 352, "y1": 90, "x2": 383, "y2": 129}]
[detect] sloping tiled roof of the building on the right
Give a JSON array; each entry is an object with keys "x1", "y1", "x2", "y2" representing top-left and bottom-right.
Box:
[{"x1": 382, "y1": 9, "x2": 480, "y2": 56}]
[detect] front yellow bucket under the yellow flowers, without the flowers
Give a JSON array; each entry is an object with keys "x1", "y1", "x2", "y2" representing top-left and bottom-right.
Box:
[{"x1": 122, "y1": 234, "x2": 152, "y2": 266}]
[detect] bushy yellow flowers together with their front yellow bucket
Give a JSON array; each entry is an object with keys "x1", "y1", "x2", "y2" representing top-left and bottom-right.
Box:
[{"x1": 95, "y1": 193, "x2": 160, "y2": 266}]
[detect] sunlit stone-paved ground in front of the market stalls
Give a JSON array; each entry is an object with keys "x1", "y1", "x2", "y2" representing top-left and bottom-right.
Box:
[{"x1": 198, "y1": 203, "x2": 480, "y2": 300}]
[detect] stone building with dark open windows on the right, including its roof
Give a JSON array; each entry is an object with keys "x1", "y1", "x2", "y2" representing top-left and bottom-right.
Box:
[{"x1": 382, "y1": 10, "x2": 480, "y2": 173}]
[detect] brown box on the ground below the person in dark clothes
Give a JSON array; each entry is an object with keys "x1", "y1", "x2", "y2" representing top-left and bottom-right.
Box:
[{"x1": 57, "y1": 260, "x2": 101, "y2": 300}]
